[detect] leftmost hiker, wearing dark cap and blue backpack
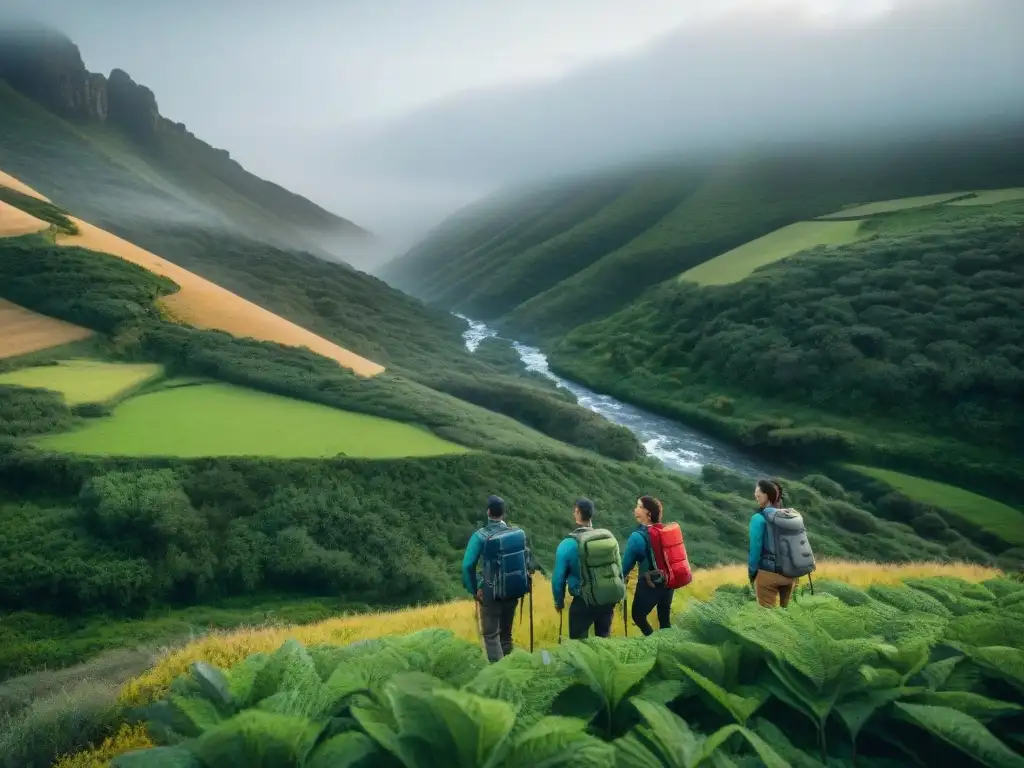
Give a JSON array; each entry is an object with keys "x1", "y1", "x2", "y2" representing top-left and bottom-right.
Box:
[{"x1": 462, "y1": 496, "x2": 534, "y2": 662}]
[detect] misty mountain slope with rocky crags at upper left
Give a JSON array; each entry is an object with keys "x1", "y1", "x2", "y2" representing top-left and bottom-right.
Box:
[{"x1": 0, "y1": 27, "x2": 372, "y2": 268}]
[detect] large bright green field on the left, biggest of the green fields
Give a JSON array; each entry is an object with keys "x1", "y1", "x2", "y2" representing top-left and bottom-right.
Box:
[{"x1": 38, "y1": 384, "x2": 465, "y2": 459}]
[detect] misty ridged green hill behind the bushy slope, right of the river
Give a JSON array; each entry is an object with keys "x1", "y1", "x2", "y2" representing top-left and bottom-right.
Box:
[{"x1": 379, "y1": 125, "x2": 1024, "y2": 339}]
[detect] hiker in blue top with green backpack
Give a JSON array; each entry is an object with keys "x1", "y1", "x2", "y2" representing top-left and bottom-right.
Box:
[{"x1": 551, "y1": 498, "x2": 626, "y2": 640}]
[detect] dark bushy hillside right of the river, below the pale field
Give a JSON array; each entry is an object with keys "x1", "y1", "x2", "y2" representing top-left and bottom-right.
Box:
[{"x1": 552, "y1": 201, "x2": 1024, "y2": 518}]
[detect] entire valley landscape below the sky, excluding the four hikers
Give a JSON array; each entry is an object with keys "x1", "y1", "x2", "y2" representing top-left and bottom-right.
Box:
[{"x1": 0, "y1": 16, "x2": 1024, "y2": 768}]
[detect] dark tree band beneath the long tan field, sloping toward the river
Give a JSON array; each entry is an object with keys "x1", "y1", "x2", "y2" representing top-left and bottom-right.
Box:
[{"x1": 0, "y1": 237, "x2": 643, "y2": 459}]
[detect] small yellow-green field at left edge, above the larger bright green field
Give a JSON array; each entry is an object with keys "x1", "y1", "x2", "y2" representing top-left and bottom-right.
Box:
[{"x1": 0, "y1": 359, "x2": 164, "y2": 406}]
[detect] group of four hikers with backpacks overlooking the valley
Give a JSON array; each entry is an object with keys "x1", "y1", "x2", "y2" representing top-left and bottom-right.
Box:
[{"x1": 462, "y1": 480, "x2": 815, "y2": 662}]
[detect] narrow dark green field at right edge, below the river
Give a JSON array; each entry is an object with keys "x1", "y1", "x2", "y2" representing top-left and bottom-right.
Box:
[{"x1": 846, "y1": 464, "x2": 1024, "y2": 546}]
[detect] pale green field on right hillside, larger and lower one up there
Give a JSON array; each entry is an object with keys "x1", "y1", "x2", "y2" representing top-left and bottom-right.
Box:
[{"x1": 679, "y1": 221, "x2": 860, "y2": 286}]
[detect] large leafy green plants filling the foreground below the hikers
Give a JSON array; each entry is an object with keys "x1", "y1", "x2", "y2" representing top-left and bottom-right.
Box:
[{"x1": 79, "y1": 578, "x2": 1024, "y2": 768}]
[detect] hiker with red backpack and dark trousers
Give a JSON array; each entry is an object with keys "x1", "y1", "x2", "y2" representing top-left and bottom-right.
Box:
[{"x1": 623, "y1": 496, "x2": 693, "y2": 636}]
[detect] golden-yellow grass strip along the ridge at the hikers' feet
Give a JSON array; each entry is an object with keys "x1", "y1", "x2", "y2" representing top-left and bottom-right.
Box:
[{"x1": 54, "y1": 560, "x2": 1000, "y2": 768}]
